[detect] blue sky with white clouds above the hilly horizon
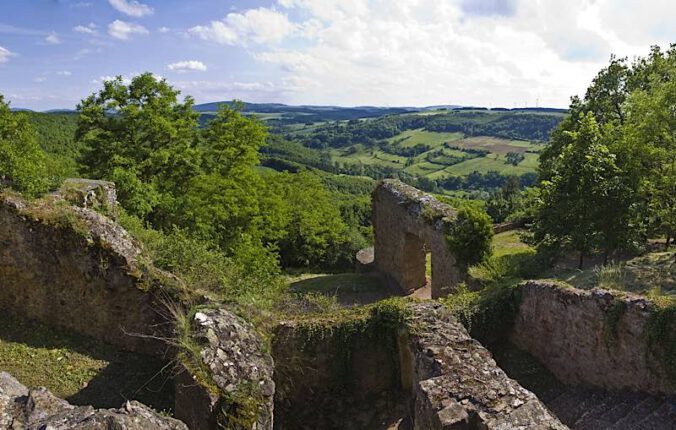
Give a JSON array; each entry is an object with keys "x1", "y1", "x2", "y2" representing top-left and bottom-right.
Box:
[{"x1": 0, "y1": 0, "x2": 676, "y2": 110}]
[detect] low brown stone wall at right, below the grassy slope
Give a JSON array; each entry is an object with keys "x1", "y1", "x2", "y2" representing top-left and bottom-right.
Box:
[{"x1": 512, "y1": 281, "x2": 676, "y2": 394}]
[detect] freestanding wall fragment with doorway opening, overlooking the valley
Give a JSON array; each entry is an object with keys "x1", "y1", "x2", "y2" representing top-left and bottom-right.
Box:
[{"x1": 373, "y1": 179, "x2": 462, "y2": 298}]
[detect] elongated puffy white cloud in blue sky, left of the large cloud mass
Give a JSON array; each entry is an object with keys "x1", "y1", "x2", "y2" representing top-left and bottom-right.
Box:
[{"x1": 188, "y1": 7, "x2": 296, "y2": 45}]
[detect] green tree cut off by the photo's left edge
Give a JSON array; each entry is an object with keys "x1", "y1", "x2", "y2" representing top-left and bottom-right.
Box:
[{"x1": 0, "y1": 94, "x2": 49, "y2": 196}]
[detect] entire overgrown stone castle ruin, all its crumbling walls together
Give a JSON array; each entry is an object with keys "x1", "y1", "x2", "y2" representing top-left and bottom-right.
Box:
[{"x1": 0, "y1": 180, "x2": 676, "y2": 430}]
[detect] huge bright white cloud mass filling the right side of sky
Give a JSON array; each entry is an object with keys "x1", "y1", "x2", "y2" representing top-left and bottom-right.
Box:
[{"x1": 222, "y1": 0, "x2": 676, "y2": 107}]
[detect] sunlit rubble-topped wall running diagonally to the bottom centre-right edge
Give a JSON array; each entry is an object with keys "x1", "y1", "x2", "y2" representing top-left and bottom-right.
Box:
[{"x1": 409, "y1": 302, "x2": 567, "y2": 430}]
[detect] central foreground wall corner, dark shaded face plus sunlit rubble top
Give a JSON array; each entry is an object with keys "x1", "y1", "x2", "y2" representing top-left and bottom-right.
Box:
[{"x1": 273, "y1": 302, "x2": 567, "y2": 430}]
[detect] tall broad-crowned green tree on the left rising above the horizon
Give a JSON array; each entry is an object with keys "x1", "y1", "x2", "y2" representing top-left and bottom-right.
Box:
[{"x1": 76, "y1": 73, "x2": 200, "y2": 221}]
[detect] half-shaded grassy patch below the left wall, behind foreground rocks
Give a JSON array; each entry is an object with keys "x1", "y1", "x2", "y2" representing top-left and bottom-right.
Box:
[{"x1": 0, "y1": 314, "x2": 173, "y2": 412}]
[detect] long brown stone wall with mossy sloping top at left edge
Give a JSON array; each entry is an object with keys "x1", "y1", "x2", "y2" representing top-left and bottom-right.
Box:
[{"x1": 0, "y1": 197, "x2": 170, "y2": 356}]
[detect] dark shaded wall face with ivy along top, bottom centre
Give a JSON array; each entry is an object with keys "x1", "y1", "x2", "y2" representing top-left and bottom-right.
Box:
[{"x1": 272, "y1": 321, "x2": 407, "y2": 430}]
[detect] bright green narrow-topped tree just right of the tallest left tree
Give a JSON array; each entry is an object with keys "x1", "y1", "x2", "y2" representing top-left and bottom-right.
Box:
[{"x1": 172, "y1": 106, "x2": 279, "y2": 249}]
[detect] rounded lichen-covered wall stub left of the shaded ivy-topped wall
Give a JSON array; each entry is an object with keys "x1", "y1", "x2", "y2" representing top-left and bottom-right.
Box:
[{"x1": 175, "y1": 309, "x2": 275, "y2": 430}]
